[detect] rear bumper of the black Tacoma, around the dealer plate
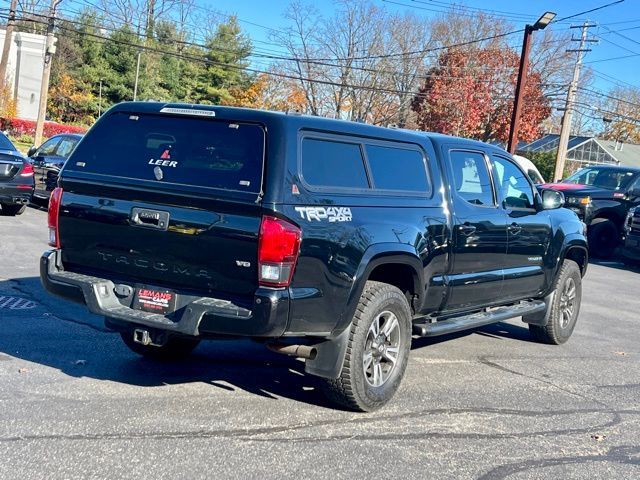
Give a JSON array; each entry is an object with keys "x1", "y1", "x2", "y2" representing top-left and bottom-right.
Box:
[{"x1": 40, "y1": 250, "x2": 289, "y2": 338}]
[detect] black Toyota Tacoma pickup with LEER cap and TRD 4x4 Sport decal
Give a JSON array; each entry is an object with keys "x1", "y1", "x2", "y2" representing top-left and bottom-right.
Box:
[{"x1": 41, "y1": 103, "x2": 588, "y2": 411}]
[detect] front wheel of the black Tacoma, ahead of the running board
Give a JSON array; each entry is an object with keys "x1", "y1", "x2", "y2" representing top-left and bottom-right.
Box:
[{"x1": 529, "y1": 260, "x2": 582, "y2": 345}]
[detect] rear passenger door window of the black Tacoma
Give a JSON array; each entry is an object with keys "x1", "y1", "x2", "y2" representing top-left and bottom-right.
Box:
[{"x1": 449, "y1": 150, "x2": 495, "y2": 207}]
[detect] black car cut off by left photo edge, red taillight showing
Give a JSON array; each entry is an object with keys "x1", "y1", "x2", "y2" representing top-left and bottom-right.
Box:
[{"x1": 0, "y1": 133, "x2": 33, "y2": 216}]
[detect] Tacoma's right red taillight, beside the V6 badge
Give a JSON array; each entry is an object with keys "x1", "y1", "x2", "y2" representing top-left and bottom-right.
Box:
[{"x1": 258, "y1": 216, "x2": 302, "y2": 287}]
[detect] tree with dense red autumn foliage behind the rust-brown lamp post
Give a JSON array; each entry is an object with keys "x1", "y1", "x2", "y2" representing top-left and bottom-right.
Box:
[{"x1": 412, "y1": 47, "x2": 551, "y2": 142}]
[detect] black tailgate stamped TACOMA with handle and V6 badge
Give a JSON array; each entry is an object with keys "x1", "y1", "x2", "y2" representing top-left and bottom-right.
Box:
[{"x1": 59, "y1": 181, "x2": 261, "y2": 295}]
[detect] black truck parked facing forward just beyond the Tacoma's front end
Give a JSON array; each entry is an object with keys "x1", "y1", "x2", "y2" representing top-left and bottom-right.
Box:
[{"x1": 542, "y1": 165, "x2": 640, "y2": 258}]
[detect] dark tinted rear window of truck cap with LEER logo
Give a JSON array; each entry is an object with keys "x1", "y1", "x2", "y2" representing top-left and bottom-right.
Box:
[{"x1": 65, "y1": 112, "x2": 265, "y2": 193}]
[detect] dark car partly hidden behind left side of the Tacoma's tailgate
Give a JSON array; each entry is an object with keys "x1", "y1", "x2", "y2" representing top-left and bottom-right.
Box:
[{"x1": 27, "y1": 133, "x2": 82, "y2": 204}]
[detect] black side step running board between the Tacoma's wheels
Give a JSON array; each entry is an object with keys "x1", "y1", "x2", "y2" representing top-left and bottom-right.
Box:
[{"x1": 413, "y1": 300, "x2": 546, "y2": 337}]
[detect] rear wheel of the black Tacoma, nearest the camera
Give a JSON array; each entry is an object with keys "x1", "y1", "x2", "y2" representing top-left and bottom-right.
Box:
[{"x1": 324, "y1": 281, "x2": 411, "y2": 412}]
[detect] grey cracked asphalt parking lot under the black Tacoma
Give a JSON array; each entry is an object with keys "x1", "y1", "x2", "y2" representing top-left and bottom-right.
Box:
[{"x1": 0, "y1": 208, "x2": 640, "y2": 479}]
